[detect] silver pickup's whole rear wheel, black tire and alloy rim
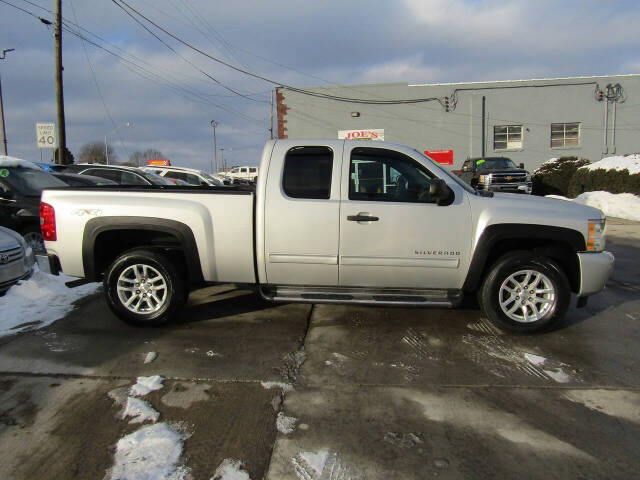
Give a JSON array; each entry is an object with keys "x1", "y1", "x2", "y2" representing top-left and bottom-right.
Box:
[{"x1": 104, "y1": 249, "x2": 188, "y2": 327}]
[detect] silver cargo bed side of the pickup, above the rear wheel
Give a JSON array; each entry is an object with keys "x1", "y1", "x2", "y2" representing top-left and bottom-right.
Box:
[{"x1": 42, "y1": 185, "x2": 256, "y2": 283}]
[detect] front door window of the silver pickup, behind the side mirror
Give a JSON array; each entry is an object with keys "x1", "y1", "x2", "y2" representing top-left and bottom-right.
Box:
[{"x1": 349, "y1": 147, "x2": 434, "y2": 203}]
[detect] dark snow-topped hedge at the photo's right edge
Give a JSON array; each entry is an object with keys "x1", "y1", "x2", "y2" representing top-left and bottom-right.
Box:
[{"x1": 569, "y1": 168, "x2": 640, "y2": 197}]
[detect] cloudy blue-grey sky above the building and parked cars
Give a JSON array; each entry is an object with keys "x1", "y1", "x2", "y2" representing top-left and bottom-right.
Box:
[{"x1": 0, "y1": 0, "x2": 640, "y2": 170}]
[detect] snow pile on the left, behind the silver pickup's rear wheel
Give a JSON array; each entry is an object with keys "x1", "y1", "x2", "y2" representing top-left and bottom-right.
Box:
[{"x1": 0, "y1": 267, "x2": 100, "y2": 337}]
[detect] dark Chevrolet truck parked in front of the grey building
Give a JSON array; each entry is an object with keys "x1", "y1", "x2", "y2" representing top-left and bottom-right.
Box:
[{"x1": 455, "y1": 157, "x2": 532, "y2": 194}]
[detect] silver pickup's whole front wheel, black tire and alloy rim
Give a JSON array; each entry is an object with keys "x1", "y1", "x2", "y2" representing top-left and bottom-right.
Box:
[{"x1": 478, "y1": 252, "x2": 571, "y2": 333}]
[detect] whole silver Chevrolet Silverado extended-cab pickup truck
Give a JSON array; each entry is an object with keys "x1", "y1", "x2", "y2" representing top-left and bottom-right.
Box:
[{"x1": 41, "y1": 140, "x2": 614, "y2": 332}]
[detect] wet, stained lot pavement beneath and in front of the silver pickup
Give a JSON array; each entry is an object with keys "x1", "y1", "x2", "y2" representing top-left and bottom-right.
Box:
[{"x1": 0, "y1": 220, "x2": 640, "y2": 480}]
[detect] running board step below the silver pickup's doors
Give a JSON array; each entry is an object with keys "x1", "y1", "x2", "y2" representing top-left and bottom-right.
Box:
[{"x1": 260, "y1": 285, "x2": 463, "y2": 308}]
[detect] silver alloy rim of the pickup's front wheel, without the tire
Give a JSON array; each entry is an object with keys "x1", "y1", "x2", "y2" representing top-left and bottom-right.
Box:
[{"x1": 498, "y1": 270, "x2": 556, "y2": 323}]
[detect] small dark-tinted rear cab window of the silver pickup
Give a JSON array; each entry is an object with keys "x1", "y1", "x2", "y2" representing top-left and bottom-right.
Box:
[{"x1": 282, "y1": 147, "x2": 333, "y2": 200}]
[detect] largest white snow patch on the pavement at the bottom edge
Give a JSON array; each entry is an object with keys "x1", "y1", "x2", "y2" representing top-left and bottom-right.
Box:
[{"x1": 108, "y1": 422, "x2": 188, "y2": 480}]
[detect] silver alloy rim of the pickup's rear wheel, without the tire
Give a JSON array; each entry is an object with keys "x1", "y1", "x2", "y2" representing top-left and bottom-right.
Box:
[{"x1": 117, "y1": 264, "x2": 168, "y2": 313}]
